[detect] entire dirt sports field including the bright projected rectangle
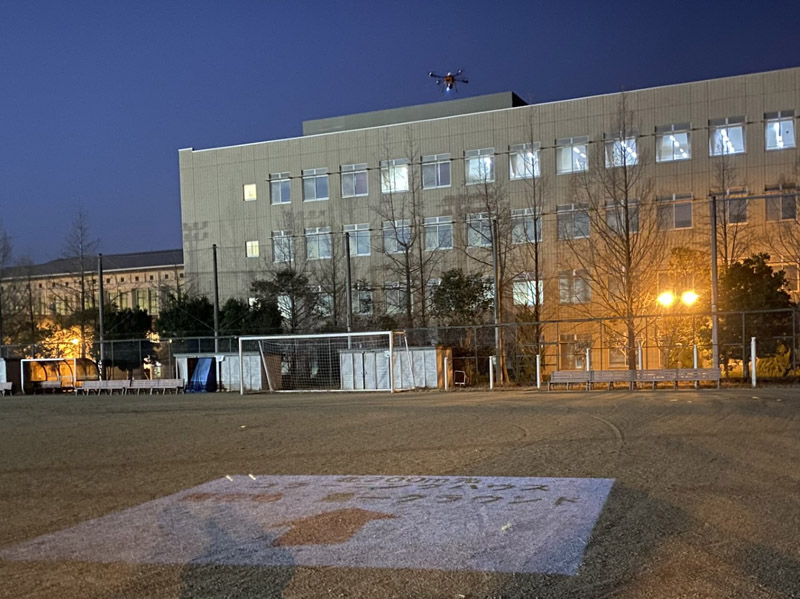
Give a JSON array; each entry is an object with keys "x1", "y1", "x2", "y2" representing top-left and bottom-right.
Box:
[{"x1": 0, "y1": 388, "x2": 800, "y2": 599}]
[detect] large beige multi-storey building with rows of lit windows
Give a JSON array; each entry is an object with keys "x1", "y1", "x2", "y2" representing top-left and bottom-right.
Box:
[{"x1": 179, "y1": 68, "x2": 800, "y2": 350}]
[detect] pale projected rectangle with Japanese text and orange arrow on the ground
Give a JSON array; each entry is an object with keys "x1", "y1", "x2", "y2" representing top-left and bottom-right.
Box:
[{"x1": 0, "y1": 475, "x2": 614, "y2": 575}]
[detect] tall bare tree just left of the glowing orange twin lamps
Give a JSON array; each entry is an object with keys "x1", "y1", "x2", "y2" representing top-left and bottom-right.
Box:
[{"x1": 559, "y1": 94, "x2": 666, "y2": 370}]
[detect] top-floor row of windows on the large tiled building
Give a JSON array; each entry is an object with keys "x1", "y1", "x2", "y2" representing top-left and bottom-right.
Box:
[{"x1": 243, "y1": 110, "x2": 795, "y2": 204}]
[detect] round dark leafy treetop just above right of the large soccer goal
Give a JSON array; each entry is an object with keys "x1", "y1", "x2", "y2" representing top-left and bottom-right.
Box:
[{"x1": 431, "y1": 268, "x2": 493, "y2": 326}]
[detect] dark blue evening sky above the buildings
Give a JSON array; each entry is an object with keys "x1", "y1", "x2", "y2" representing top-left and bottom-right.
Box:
[{"x1": 0, "y1": 0, "x2": 800, "y2": 261}]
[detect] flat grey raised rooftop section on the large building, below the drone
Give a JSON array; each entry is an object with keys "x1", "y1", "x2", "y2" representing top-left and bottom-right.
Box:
[{"x1": 303, "y1": 92, "x2": 527, "y2": 135}]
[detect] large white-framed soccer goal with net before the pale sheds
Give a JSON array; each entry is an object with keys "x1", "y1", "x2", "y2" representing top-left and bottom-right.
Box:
[{"x1": 239, "y1": 331, "x2": 415, "y2": 394}]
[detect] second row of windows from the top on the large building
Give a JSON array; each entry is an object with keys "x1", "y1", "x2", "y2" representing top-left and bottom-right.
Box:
[{"x1": 245, "y1": 193, "x2": 797, "y2": 263}]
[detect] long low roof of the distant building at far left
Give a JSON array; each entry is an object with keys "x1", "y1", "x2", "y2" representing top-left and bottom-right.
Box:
[{"x1": 6, "y1": 249, "x2": 183, "y2": 278}]
